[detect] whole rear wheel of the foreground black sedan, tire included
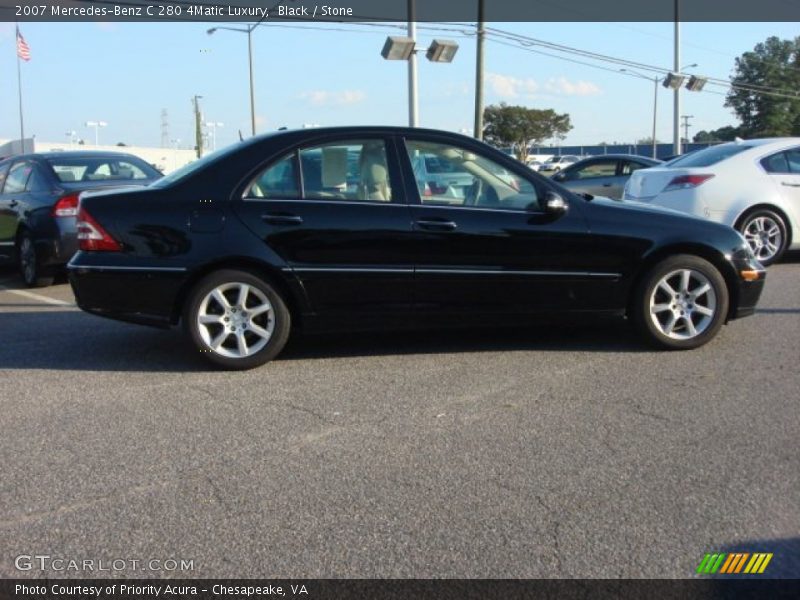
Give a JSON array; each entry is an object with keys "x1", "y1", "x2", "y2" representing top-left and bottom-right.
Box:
[{"x1": 183, "y1": 269, "x2": 291, "y2": 370}]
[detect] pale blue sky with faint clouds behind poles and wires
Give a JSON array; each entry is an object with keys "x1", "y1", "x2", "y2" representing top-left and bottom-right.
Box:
[{"x1": 0, "y1": 22, "x2": 799, "y2": 148}]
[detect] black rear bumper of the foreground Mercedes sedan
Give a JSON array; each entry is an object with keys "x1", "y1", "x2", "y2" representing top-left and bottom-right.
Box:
[{"x1": 67, "y1": 252, "x2": 188, "y2": 327}]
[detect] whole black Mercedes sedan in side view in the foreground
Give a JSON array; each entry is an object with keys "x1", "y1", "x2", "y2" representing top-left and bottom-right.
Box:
[{"x1": 69, "y1": 127, "x2": 765, "y2": 369}]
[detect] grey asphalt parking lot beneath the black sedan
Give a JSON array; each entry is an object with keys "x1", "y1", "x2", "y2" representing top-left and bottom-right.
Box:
[{"x1": 0, "y1": 256, "x2": 800, "y2": 578}]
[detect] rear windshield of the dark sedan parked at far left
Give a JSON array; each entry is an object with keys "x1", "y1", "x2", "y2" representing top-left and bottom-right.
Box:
[{"x1": 47, "y1": 156, "x2": 161, "y2": 183}]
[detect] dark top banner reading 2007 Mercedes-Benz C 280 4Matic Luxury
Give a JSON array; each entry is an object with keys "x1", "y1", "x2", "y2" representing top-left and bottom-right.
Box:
[{"x1": 0, "y1": 0, "x2": 800, "y2": 23}]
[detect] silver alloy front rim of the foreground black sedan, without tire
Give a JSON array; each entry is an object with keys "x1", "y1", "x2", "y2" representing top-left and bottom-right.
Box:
[{"x1": 649, "y1": 269, "x2": 717, "y2": 340}]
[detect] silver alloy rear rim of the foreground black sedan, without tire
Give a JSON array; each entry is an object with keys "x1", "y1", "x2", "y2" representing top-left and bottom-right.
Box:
[{"x1": 196, "y1": 282, "x2": 275, "y2": 358}]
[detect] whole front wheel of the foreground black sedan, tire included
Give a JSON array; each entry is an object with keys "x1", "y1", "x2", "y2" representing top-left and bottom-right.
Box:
[{"x1": 633, "y1": 254, "x2": 730, "y2": 350}]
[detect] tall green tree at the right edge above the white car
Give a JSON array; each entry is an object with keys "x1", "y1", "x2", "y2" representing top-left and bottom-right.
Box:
[{"x1": 725, "y1": 36, "x2": 800, "y2": 137}]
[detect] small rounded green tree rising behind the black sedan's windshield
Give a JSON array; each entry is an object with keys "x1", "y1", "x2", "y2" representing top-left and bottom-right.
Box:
[{"x1": 483, "y1": 102, "x2": 572, "y2": 162}]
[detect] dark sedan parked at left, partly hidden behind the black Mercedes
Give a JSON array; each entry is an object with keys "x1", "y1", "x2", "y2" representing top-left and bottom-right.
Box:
[{"x1": 0, "y1": 150, "x2": 161, "y2": 287}]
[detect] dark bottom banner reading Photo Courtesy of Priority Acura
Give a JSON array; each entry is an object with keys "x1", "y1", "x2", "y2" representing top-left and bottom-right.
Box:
[{"x1": 0, "y1": 578, "x2": 800, "y2": 600}]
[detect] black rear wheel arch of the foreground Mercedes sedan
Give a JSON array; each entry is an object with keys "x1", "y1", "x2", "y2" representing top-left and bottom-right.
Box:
[{"x1": 170, "y1": 257, "x2": 308, "y2": 327}]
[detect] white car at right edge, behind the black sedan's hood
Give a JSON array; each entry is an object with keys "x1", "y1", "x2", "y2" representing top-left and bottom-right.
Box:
[{"x1": 622, "y1": 138, "x2": 800, "y2": 265}]
